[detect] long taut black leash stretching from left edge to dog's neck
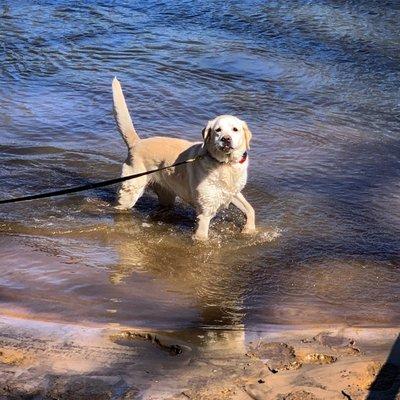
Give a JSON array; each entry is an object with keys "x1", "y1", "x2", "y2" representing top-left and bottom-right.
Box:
[{"x1": 0, "y1": 156, "x2": 201, "y2": 204}]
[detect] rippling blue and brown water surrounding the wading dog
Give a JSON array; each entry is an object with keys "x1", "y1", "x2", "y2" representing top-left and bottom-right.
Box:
[{"x1": 0, "y1": 0, "x2": 400, "y2": 329}]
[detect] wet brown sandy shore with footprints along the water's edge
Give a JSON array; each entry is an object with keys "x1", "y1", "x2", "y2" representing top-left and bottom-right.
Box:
[{"x1": 0, "y1": 313, "x2": 400, "y2": 400}]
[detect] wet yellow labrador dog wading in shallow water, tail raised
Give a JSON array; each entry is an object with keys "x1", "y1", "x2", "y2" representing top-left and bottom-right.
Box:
[{"x1": 112, "y1": 78, "x2": 255, "y2": 240}]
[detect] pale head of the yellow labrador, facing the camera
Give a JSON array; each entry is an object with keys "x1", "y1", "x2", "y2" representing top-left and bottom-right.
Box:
[{"x1": 202, "y1": 115, "x2": 251, "y2": 162}]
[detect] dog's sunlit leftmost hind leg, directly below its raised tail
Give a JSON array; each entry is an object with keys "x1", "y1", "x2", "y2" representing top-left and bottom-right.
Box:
[{"x1": 115, "y1": 163, "x2": 148, "y2": 210}]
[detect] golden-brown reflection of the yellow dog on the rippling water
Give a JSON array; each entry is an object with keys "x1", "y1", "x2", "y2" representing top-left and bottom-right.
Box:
[{"x1": 110, "y1": 212, "x2": 250, "y2": 354}]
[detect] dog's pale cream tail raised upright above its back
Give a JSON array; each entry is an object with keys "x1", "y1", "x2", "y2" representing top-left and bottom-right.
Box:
[{"x1": 112, "y1": 78, "x2": 140, "y2": 149}]
